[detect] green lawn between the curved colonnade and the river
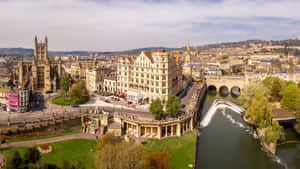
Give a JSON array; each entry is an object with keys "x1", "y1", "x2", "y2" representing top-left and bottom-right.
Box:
[{"x1": 145, "y1": 132, "x2": 197, "y2": 169}]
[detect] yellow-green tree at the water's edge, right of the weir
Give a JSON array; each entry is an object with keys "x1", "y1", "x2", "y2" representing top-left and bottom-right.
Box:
[{"x1": 246, "y1": 92, "x2": 272, "y2": 127}]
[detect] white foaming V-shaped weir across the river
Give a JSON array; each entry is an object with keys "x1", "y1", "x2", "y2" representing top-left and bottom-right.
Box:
[{"x1": 200, "y1": 99, "x2": 245, "y2": 128}]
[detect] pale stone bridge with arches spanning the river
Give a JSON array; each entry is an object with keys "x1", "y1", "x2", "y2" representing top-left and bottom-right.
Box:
[{"x1": 205, "y1": 75, "x2": 248, "y2": 92}]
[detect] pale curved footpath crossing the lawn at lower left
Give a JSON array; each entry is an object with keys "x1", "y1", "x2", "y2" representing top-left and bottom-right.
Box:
[{"x1": 0, "y1": 133, "x2": 96, "y2": 149}]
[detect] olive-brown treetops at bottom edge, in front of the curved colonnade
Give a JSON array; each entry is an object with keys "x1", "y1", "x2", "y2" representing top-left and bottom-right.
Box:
[{"x1": 95, "y1": 133, "x2": 171, "y2": 169}]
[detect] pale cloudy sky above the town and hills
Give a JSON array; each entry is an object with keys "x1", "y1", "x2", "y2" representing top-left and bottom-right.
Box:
[{"x1": 0, "y1": 0, "x2": 300, "y2": 51}]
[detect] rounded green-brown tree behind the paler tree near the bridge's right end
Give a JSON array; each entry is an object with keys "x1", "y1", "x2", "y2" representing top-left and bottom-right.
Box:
[{"x1": 262, "y1": 76, "x2": 283, "y2": 100}]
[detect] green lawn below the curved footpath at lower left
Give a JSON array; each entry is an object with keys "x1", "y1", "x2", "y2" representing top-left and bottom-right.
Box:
[{"x1": 0, "y1": 139, "x2": 97, "y2": 169}]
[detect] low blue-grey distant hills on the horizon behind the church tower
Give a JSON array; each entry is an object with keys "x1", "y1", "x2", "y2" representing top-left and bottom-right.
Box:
[{"x1": 0, "y1": 47, "x2": 176, "y2": 56}]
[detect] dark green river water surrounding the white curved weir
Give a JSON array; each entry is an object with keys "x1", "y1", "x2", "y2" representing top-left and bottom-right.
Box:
[{"x1": 196, "y1": 95, "x2": 300, "y2": 169}]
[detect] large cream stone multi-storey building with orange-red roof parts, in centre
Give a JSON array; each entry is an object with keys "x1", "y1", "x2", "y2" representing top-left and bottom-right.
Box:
[{"x1": 117, "y1": 50, "x2": 183, "y2": 103}]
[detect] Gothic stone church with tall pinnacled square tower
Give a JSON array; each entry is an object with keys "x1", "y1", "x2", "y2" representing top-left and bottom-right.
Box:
[{"x1": 19, "y1": 36, "x2": 62, "y2": 91}]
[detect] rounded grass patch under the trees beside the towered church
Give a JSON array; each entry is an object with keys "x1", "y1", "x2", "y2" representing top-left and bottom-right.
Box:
[{"x1": 51, "y1": 96, "x2": 90, "y2": 105}]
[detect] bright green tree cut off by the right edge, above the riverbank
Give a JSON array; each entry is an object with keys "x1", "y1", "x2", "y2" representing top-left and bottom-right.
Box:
[{"x1": 280, "y1": 84, "x2": 300, "y2": 110}]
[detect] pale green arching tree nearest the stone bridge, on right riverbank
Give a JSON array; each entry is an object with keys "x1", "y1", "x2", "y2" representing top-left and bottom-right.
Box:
[{"x1": 238, "y1": 81, "x2": 271, "y2": 109}]
